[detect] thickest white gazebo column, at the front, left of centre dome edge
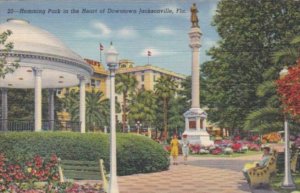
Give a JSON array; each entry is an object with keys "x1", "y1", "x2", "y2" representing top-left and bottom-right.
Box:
[{"x1": 33, "y1": 68, "x2": 42, "y2": 131}]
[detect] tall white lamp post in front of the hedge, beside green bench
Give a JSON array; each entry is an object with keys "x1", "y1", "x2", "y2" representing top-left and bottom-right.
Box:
[{"x1": 106, "y1": 43, "x2": 119, "y2": 193}]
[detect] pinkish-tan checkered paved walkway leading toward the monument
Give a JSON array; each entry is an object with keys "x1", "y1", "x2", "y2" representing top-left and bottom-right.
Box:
[{"x1": 118, "y1": 155, "x2": 273, "y2": 193}]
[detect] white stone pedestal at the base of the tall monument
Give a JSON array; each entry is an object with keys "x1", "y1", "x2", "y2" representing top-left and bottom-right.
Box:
[{"x1": 183, "y1": 108, "x2": 214, "y2": 146}]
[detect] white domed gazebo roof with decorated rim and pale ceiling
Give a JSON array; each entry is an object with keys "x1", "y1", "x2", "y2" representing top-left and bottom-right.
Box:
[{"x1": 0, "y1": 19, "x2": 93, "y2": 88}]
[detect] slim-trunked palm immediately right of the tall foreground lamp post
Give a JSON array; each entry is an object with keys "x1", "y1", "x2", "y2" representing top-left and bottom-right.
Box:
[{"x1": 116, "y1": 74, "x2": 138, "y2": 132}]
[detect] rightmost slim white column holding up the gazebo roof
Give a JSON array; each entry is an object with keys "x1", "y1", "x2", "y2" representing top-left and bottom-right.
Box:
[{"x1": 78, "y1": 75, "x2": 85, "y2": 133}]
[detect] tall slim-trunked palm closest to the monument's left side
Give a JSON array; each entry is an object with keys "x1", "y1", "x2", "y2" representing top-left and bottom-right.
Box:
[{"x1": 154, "y1": 76, "x2": 177, "y2": 139}]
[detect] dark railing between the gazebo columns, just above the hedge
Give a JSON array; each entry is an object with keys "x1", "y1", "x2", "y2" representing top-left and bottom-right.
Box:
[{"x1": 0, "y1": 119, "x2": 80, "y2": 132}]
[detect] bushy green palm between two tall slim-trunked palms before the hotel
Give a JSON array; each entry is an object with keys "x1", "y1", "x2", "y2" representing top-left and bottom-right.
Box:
[{"x1": 128, "y1": 90, "x2": 158, "y2": 133}]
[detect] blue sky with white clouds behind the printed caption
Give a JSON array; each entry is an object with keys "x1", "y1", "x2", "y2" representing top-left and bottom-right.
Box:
[{"x1": 0, "y1": 0, "x2": 218, "y2": 75}]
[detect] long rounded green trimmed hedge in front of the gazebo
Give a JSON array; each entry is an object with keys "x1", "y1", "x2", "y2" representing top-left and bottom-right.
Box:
[{"x1": 0, "y1": 132, "x2": 170, "y2": 175}]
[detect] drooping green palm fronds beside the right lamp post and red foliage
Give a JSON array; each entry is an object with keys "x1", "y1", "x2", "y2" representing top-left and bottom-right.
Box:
[{"x1": 244, "y1": 36, "x2": 300, "y2": 132}]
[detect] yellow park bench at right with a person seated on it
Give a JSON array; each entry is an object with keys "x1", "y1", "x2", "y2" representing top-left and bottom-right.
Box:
[{"x1": 248, "y1": 151, "x2": 277, "y2": 188}]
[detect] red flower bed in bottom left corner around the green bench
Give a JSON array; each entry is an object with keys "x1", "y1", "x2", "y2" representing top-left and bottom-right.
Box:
[{"x1": 0, "y1": 154, "x2": 102, "y2": 193}]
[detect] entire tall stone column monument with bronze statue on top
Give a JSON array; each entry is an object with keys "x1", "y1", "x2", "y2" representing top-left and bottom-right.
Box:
[{"x1": 183, "y1": 3, "x2": 213, "y2": 145}]
